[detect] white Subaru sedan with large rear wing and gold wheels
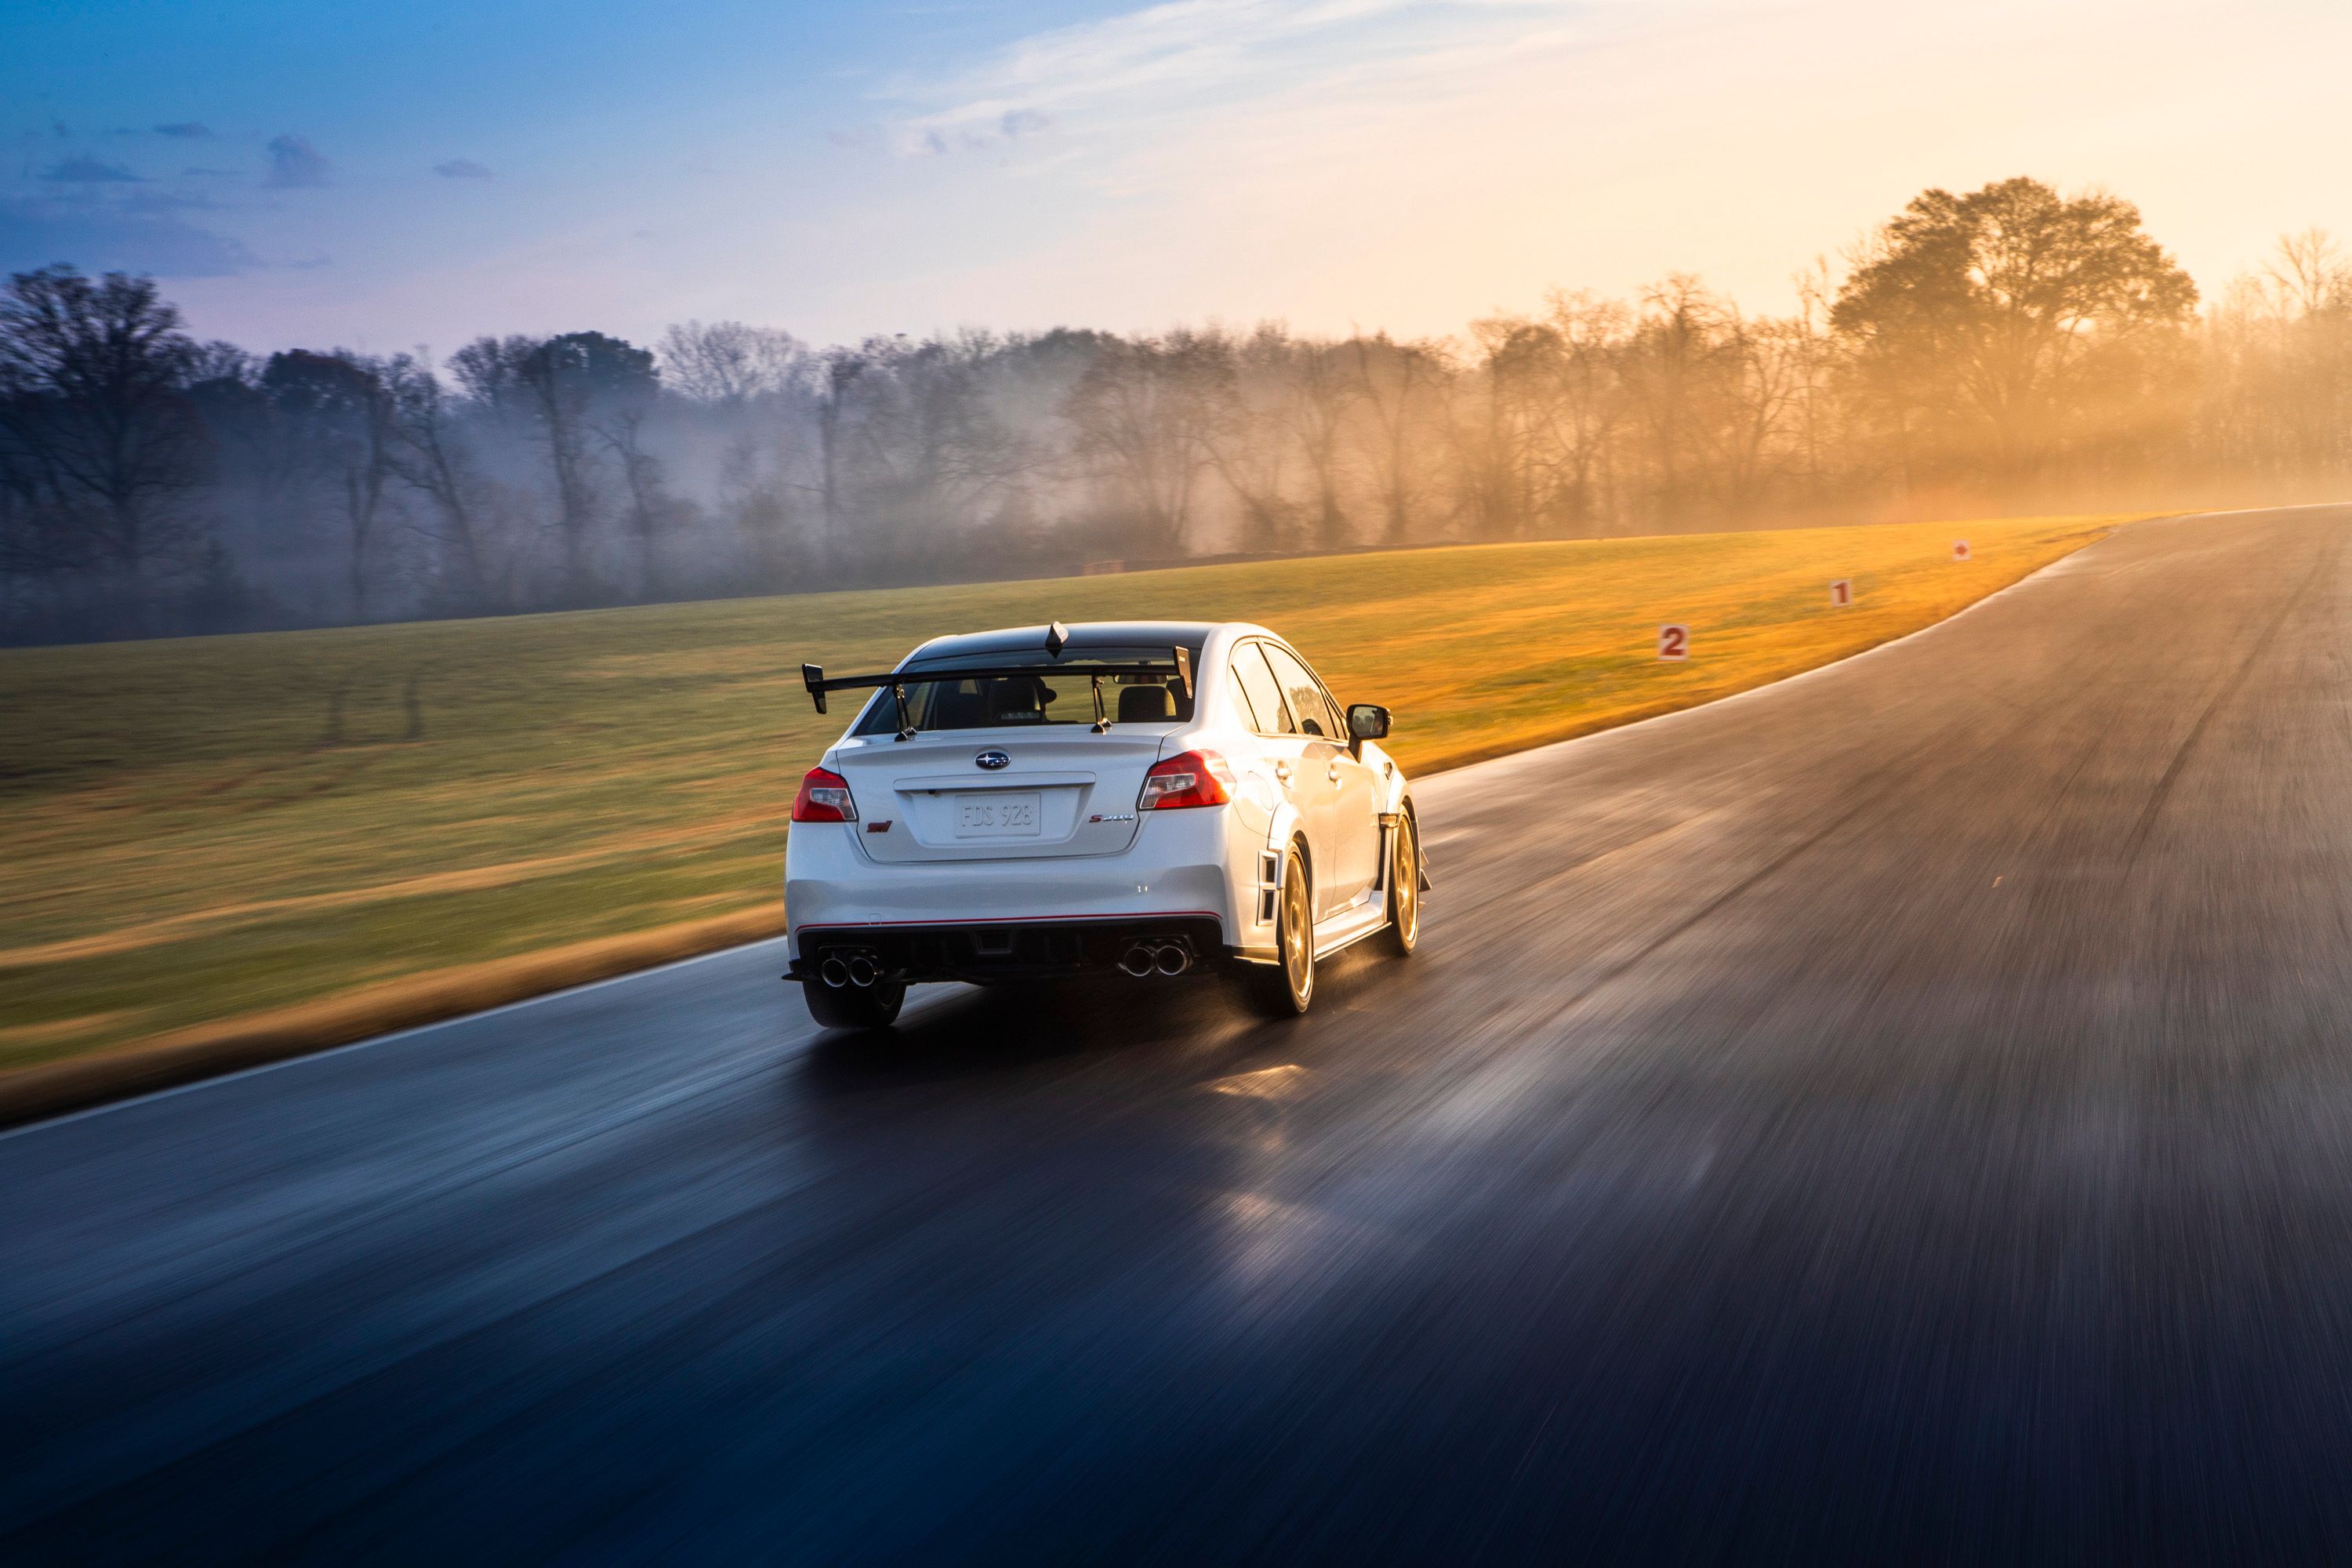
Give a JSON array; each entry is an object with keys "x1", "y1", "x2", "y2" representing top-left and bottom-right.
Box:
[{"x1": 783, "y1": 621, "x2": 1428, "y2": 1029}]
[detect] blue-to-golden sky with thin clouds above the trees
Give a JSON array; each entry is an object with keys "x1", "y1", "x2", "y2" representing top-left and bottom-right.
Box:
[{"x1": 0, "y1": 0, "x2": 2352, "y2": 353}]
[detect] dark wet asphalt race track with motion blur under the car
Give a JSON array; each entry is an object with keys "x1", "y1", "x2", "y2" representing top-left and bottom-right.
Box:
[{"x1": 13, "y1": 510, "x2": 2352, "y2": 1563}]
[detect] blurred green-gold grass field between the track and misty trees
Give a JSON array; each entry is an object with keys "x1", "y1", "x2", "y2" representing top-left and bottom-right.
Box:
[{"x1": 0, "y1": 517, "x2": 2114, "y2": 1091}]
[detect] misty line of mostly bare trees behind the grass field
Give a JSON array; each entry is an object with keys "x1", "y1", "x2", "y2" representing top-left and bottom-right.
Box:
[{"x1": 0, "y1": 179, "x2": 2352, "y2": 642}]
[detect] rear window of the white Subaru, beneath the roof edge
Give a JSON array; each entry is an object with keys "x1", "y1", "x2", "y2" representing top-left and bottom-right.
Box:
[{"x1": 849, "y1": 647, "x2": 1200, "y2": 736}]
